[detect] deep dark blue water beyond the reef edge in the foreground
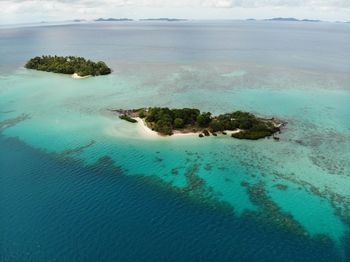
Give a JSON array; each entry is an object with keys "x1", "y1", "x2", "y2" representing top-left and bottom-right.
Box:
[{"x1": 0, "y1": 136, "x2": 341, "y2": 262}]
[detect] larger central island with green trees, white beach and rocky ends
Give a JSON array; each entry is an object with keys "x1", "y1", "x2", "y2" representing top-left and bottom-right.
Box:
[{"x1": 111, "y1": 107, "x2": 286, "y2": 140}]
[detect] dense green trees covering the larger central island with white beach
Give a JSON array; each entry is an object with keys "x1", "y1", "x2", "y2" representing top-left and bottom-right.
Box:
[{"x1": 130, "y1": 107, "x2": 280, "y2": 139}]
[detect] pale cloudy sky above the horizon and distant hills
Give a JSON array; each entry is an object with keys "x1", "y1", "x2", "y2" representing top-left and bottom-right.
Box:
[{"x1": 0, "y1": 0, "x2": 350, "y2": 24}]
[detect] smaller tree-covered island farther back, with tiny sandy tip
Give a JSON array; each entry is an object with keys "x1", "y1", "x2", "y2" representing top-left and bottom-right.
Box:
[{"x1": 25, "y1": 56, "x2": 111, "y2": 78}]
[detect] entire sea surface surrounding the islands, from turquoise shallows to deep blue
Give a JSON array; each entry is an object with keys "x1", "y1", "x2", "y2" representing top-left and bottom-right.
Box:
[{"x1": 0, "y1": 21, "x2": 350, "y2": 262}]
